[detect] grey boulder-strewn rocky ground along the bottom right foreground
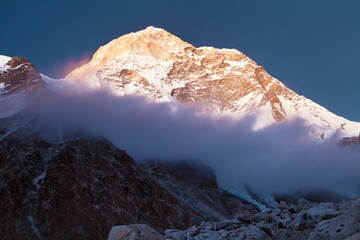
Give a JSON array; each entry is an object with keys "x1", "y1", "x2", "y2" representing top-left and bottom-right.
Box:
[{"x1": 108, "y1": 198, "x2": 360, "y2": 240}]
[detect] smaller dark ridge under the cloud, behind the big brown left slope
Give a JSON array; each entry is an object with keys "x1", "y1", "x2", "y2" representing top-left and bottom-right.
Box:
[{"x1": 142, "y1": 162, "x2": 232, "y2": 219}]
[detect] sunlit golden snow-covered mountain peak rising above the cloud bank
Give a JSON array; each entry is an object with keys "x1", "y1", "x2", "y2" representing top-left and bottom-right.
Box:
[{"x1": 66, "y1": 27, "x2": 360, "y2": 138}]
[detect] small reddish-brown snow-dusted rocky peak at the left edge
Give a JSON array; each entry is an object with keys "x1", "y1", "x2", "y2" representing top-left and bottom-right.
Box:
[{"x1": 0, "y1": 57, "x2": 45, "y2": 96}]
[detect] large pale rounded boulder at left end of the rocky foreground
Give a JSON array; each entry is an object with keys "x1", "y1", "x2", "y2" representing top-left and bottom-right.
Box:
[{"x1": 108, "y1": 224, "x2": 165, "y2": 240}]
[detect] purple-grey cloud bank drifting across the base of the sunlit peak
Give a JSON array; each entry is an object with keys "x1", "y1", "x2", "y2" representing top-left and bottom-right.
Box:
[{"x1": 28, "y1": 87, "x2": 360, "y2": 196}]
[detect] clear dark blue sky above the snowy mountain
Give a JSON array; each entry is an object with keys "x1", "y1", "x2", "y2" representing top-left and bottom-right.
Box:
[{"x1": 0, "y1": 0, "x2": 360, "y2": 121}]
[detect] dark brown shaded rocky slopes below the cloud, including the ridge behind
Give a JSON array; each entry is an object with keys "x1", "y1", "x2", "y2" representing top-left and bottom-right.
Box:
[{"x1": 0, "y1": 125, "x2": 250, "y2": 239}]
